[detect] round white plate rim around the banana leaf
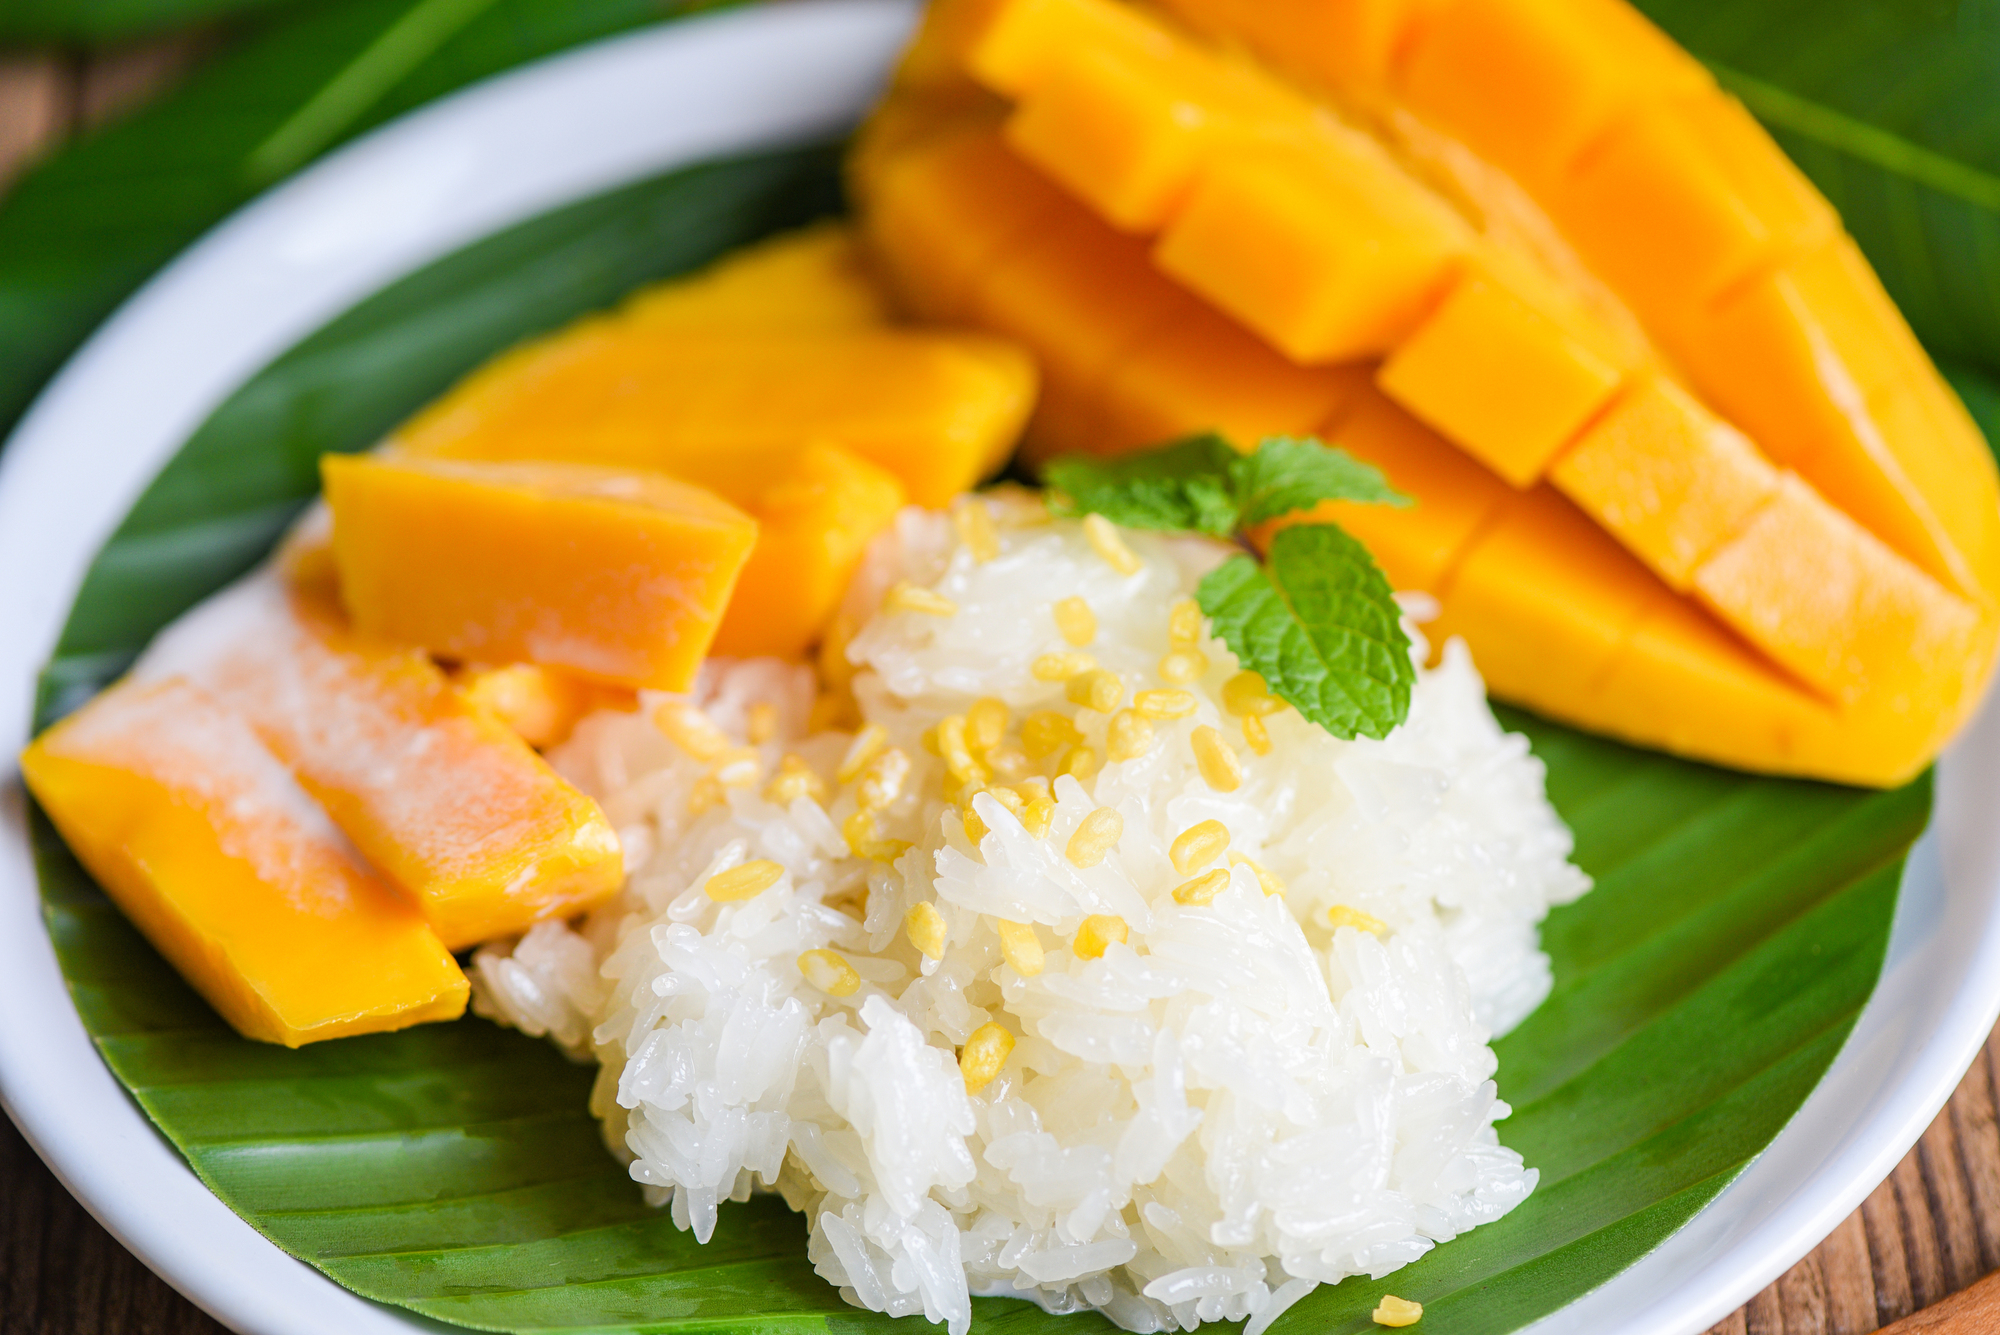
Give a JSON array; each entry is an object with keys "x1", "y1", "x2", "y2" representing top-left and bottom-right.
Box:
[{"x1": 0, "y1": 0, "x2": 2000, "y2": 1335}]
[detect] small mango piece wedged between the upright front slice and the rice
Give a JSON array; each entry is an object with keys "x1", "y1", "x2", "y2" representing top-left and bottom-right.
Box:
[{"x1": 712, "y1": 446, "x2": 904, "y2": 658}]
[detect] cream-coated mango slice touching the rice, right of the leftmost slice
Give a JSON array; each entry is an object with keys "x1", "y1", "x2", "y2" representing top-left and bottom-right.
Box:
[{"x1": 134, "y1": 572, "x2": 624, "y2": 949}]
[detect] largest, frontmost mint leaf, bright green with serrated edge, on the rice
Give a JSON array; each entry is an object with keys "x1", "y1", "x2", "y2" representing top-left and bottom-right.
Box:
[{"x1": 1194, "y1": 524, "x2": 1416, "y2": 739}]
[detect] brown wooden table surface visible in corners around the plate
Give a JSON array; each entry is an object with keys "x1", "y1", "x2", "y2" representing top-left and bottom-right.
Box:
[{"x1": 0, "y1": 36, "x2": 2000, "y2": 1335}]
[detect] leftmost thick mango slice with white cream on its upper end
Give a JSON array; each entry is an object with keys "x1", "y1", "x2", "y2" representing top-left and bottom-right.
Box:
[{"x1": 20, "y1": 677, "x2": 468, "y2": 1047}]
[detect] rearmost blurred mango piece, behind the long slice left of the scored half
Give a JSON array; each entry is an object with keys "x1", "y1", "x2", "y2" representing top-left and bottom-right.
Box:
[{"x1": 620, "y1": 222, "x2": 890, "y2": 334}]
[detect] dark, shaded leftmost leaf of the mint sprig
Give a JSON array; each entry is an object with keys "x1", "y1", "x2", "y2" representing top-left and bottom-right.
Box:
[{"x1": 1042, "y1": 434, "x2": 1242, "y2": 538}]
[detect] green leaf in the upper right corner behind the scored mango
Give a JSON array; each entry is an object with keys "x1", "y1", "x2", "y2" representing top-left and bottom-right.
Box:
[{"x1": 1636, "y1": 0, "x2": 2000, "y2": 372}]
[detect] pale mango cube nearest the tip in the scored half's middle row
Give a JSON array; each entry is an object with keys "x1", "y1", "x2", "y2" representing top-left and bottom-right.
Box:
[{"x1": 1694, "y1": 476, "x2": 1984, "y2": 717}]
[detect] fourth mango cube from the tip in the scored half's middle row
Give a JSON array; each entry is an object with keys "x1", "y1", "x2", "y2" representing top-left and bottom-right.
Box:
[{"x1": 1154, "y1": 136, "x2": 1470, "y2": 364}]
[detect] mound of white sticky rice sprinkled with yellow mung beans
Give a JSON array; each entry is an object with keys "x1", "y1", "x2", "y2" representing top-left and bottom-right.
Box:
[{"x1": 474, "y1": 498, "x2": 1588, "y2": 1335}]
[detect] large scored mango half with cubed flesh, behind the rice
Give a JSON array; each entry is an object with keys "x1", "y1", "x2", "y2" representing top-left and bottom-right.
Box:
[{"x1": 850, "y1": 0, "x2": 2000, "y2": 783}]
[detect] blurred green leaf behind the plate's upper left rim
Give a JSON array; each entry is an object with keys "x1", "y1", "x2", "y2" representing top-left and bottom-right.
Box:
[{"x1": 0, "y1": 0, "x2": 728, "y2": 443}]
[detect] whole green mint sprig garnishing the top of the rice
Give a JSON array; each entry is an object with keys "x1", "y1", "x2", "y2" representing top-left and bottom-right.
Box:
[{"x1": 1044, "y1": 436, "x2": 1416, "y2": 739}]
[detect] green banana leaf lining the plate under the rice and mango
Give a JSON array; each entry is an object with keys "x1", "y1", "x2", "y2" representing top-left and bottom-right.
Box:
[{"x1": 19, "y1": 137, "x2": 1930, "y2": 1335}]
